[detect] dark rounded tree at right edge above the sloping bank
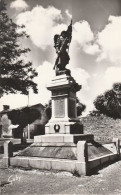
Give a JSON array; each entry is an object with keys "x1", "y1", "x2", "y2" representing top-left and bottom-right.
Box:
[{"x1": 94, "y1": 83, "x2": 121, "y2": 118}]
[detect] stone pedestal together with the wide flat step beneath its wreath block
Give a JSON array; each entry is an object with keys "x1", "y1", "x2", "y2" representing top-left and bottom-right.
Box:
[{"x1": 34, "y1": 74, "x2": 94, "y2": 149}]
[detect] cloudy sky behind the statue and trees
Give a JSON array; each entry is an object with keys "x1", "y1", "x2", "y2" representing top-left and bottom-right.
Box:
[{"x1": 0, "y1": 0, "x2": 121, "y2": 115}]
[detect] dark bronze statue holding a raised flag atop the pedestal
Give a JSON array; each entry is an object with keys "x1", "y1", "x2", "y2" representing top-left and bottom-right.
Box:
[{"x1": 54, "y1": 21, "x2": 72, "y2": 75}]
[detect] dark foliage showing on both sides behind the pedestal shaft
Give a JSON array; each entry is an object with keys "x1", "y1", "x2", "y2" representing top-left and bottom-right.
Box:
[{"x1": 45, "y1": 97, "x2": 86, "y2": 119}]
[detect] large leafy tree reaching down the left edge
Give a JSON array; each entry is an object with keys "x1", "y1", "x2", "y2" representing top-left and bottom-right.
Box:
[{"x1": 0, "y1": 0, "x2": 37, "y2": 96}]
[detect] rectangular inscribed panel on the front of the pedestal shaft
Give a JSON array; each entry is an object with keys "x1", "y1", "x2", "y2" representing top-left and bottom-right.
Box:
[{"x1": 54, "y1": 99, "x2": 65, "y2": 118}]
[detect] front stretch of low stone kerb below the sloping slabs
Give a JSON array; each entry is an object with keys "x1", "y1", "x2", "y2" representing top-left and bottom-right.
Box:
[{"x1": 10, "y1": 156, "x2": 87, "y2": 176}]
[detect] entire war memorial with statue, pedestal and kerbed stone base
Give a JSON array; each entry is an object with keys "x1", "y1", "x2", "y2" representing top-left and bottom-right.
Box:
[{"x1": 4, "y1": 22, "x2": 119, "y2": 175}]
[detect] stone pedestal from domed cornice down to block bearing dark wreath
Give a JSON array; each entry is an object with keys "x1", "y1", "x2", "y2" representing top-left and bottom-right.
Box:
[{"x1": 45, "y1": 74, "x2": 83, "y2": 134}]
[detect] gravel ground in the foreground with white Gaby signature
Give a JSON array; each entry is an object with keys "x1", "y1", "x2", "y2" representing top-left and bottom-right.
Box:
[{"x1": 0, "y1": 161, "x2": 121, "y2": 195}]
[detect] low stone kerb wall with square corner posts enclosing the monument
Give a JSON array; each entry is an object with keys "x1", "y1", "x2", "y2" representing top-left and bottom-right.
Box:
[{"x1": 3, "y1": 139, "x2": 120, "y2": 176}]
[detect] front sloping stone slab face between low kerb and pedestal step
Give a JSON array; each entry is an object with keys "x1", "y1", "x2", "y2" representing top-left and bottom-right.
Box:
[{"x1": 17, "y1": 143, "x2": 77, "y2": 160}]
